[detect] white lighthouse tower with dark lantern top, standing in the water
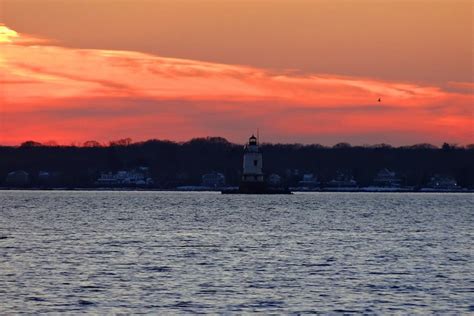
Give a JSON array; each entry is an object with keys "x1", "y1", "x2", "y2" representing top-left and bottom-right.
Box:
[{"x1": 242, "y1": 135, "x2": 264, "y2": 186}]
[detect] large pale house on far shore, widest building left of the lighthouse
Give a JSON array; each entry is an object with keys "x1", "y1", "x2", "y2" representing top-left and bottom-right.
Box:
[{"x1": 95, "y1": 167, "x2": 153, "y2": 186}]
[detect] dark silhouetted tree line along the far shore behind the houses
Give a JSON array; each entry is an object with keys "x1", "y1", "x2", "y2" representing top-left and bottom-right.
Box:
[{"x1": 0, "y1": 137, "x2": 474, "y2": 189}]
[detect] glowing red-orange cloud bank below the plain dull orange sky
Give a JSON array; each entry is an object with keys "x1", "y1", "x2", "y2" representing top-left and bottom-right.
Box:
[{"x1": 0, "y1": 25, "x2": 473, "y2": 144}]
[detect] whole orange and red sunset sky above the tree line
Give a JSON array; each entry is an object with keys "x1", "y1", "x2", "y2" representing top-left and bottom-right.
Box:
[{"x1": 0, "y1": 0, "x2": 474, "y2": 145}]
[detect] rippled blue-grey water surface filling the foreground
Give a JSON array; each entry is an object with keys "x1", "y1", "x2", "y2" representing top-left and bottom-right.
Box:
[{"x1": 0, "y1": 191, "x2": 474, "y2": 314}]
